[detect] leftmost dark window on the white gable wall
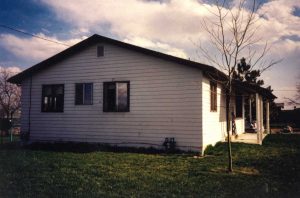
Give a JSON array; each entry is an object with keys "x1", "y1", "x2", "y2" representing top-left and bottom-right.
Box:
[{"x1": 42, "y1": 85, "x2": 64, "y2": 112}]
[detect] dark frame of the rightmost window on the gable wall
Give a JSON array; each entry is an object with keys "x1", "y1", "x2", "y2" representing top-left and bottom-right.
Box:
[{"x1": 103, "y1": 81, "x2": 130, "y2": 112}]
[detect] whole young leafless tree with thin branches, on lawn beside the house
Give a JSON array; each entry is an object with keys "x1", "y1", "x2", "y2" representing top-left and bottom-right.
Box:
[{"x1": 199, "y1": 0, "x2": 279, "y2": 172}]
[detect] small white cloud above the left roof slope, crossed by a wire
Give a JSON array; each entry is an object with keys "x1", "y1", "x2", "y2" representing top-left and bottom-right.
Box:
[{"x1": 0, "y1": 34, "x2": 82, "y2": 61}]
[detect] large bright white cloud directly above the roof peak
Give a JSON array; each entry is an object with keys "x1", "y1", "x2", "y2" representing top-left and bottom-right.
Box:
[{"x1": 43, "y1": 0, "x2": 210, "y2": 44}]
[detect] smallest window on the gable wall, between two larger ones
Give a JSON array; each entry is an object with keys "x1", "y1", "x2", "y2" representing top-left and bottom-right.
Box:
[{"x1": 75, "y1": 83, "x2": 93, "y2": 105}]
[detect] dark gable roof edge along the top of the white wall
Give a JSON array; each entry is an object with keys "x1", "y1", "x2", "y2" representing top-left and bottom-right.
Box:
[{"x1": 8, "y1": 34, "x2": 226, "y2": 84}]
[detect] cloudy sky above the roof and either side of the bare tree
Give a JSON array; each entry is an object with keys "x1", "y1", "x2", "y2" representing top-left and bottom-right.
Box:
[{"x1": 0, "y1": 0, "x2": 300, "y2": 108}]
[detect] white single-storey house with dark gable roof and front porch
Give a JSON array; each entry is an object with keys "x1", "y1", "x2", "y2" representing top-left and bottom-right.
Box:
[{"x1": 9, "y1": 35, "x2": 273, "y2": 152}]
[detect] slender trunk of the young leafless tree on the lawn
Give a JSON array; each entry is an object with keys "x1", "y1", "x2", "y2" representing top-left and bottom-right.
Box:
[{"x1": 226, "y1": 87, "x2": 233, "y2": 172}]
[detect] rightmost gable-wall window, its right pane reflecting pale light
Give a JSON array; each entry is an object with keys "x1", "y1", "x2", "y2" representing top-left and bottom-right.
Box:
[{"x1": 103, "y1": 82, "x2": 130, "y2": 112}]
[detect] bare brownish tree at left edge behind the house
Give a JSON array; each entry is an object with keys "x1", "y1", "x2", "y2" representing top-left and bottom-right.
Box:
[{"x1": 0, "y1": 67, "x2": 21, "y2": 119}]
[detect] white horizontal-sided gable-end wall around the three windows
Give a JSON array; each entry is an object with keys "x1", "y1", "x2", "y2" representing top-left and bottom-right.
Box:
[{"x1": 22, "y1": 44, "x2": 202, "y2": 151}]
